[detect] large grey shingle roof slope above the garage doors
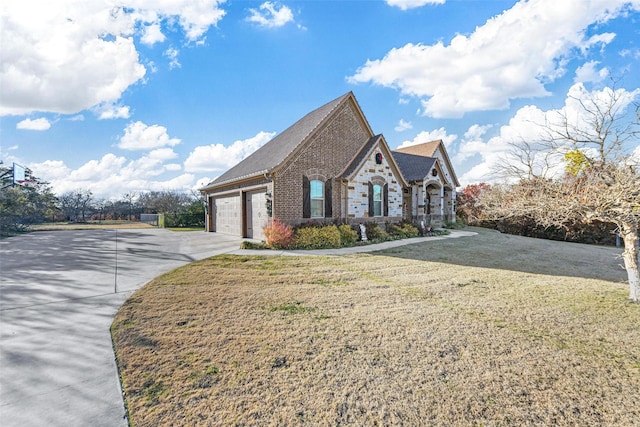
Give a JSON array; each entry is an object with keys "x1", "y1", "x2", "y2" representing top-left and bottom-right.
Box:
[{"x1": 205, "y1": 92, "x2": 353, "y2": 188}]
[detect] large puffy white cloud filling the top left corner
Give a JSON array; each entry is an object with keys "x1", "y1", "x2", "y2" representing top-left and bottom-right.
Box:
[{"x1": 0, "y1": 0, "x2": 225, "y2": 115}]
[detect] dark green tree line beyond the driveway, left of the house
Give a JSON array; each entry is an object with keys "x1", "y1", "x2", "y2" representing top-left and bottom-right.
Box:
[{"x1": 0, "y1": 163, "x2": 205, "y2": 236}]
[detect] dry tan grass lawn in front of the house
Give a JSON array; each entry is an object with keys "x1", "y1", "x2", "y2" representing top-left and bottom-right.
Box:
[{"x1": 112, "y1": 230, "x2": 640, "y2": 426}]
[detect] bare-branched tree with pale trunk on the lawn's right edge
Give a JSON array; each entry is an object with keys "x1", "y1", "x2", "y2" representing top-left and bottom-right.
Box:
[{"x1": 482, "y1": 88, "x2": 640, "y2": 302}]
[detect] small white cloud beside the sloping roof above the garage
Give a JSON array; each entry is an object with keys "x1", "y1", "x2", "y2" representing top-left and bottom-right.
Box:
[{"x1": 184, "y1": 132, "x2": 275, "y2": 172}]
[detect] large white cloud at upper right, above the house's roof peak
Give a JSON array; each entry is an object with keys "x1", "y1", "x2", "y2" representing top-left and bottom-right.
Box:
[{"x1": 348, "y1": 0, "x2": 640, "y2": 117}]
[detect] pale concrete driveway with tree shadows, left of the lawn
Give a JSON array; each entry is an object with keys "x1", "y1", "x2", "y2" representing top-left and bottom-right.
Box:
[{"x1": 0, "y1": 229, "x2": 241, "y2": 427}]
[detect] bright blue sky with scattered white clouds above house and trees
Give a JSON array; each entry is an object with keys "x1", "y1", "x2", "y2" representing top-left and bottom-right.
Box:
[{"x1": 0, "y1": 0, "x2": 640, "y2": 199}]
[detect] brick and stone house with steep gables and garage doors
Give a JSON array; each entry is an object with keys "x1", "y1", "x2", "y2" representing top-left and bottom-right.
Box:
[{"x1": 200, "y1": 92, "x2": 459, "y2": 240}]
